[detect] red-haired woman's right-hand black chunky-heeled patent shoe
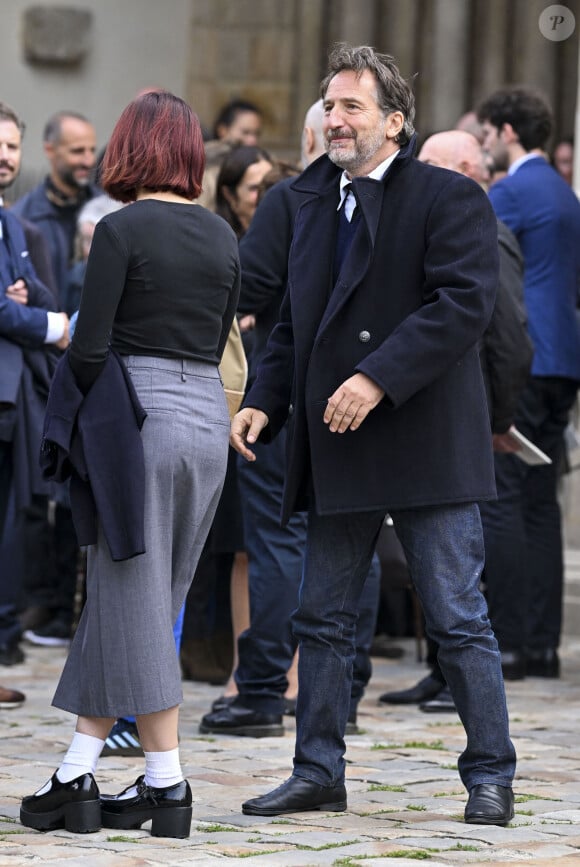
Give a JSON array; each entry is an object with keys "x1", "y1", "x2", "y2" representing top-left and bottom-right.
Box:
[{"x1": 101, "y1": 776, "x2": 192, "y2": 837}]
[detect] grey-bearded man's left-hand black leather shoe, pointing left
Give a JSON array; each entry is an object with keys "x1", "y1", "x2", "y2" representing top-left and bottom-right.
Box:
[{"x1": 242, "y1": 776, "x2": 346, "y2": 816}]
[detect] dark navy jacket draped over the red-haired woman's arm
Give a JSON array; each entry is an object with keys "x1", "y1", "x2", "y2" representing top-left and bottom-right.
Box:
[{"x1": 40, "y1": 350, "x2": 147, "y2": 560}]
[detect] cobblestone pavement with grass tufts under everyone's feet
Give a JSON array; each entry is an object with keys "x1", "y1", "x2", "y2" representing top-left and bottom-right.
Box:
[{"x1": 0, "y1": 638, "x2": 580, "y2": 867}]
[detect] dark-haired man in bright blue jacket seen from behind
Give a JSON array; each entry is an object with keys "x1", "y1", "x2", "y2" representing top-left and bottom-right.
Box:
[{"x1": 478, "y1": 87, "x2": 580, "y2": 677}]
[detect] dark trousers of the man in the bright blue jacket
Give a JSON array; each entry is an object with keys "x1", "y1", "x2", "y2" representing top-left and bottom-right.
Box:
[{"x1": 481, "y1": 377, "x2": 578, "y2": 650}]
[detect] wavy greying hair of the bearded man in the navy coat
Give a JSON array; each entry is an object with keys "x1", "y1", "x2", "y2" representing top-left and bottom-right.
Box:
[{"x1": 320, "y1": 42, "x2": 415, "y2": 145}]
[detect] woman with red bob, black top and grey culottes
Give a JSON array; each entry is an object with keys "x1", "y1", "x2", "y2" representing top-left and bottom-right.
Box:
[{"x1": 20, "y1": 91, "x2": 240, "y2": 837}]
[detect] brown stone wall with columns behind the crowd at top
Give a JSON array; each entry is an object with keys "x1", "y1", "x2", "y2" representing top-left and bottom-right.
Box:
[{"x1": 188, "y1": 0, "x2": 580, "y2": 159}]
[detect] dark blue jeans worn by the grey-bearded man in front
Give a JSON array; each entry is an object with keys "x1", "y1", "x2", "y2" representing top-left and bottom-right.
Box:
[{"x1": 293, "y1": 504, "x2": 515, "y2": 789}]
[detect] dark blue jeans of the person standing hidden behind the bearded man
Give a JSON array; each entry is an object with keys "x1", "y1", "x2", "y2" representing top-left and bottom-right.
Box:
[{"x1": 235, "y1": 429, "x2": 380, "y2": 713}]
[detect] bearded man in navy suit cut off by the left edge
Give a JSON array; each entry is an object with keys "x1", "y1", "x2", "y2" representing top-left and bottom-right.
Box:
[{"x1": 0, "y1": 103, "x2": 68, "y2": 707}]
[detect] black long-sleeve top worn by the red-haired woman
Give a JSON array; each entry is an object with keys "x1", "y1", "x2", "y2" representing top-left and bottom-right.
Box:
[{"x1": 70, "y1": 199, "x2": 240, "y2": 392}]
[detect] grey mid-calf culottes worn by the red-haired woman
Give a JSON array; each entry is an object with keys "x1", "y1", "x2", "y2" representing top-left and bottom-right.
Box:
[{"x1": 53, "y1": 355, "x2": 229, "y2": 718}]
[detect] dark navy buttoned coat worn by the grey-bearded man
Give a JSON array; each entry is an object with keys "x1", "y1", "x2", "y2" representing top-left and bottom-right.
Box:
[{"x1": 244, "y1": 137, "x2": 498, "y2": 520}]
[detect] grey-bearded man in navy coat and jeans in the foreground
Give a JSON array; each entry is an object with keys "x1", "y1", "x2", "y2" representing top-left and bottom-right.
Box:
[{"x1": 231, "y1": 45, "x2": 515, "y2": 825}]
